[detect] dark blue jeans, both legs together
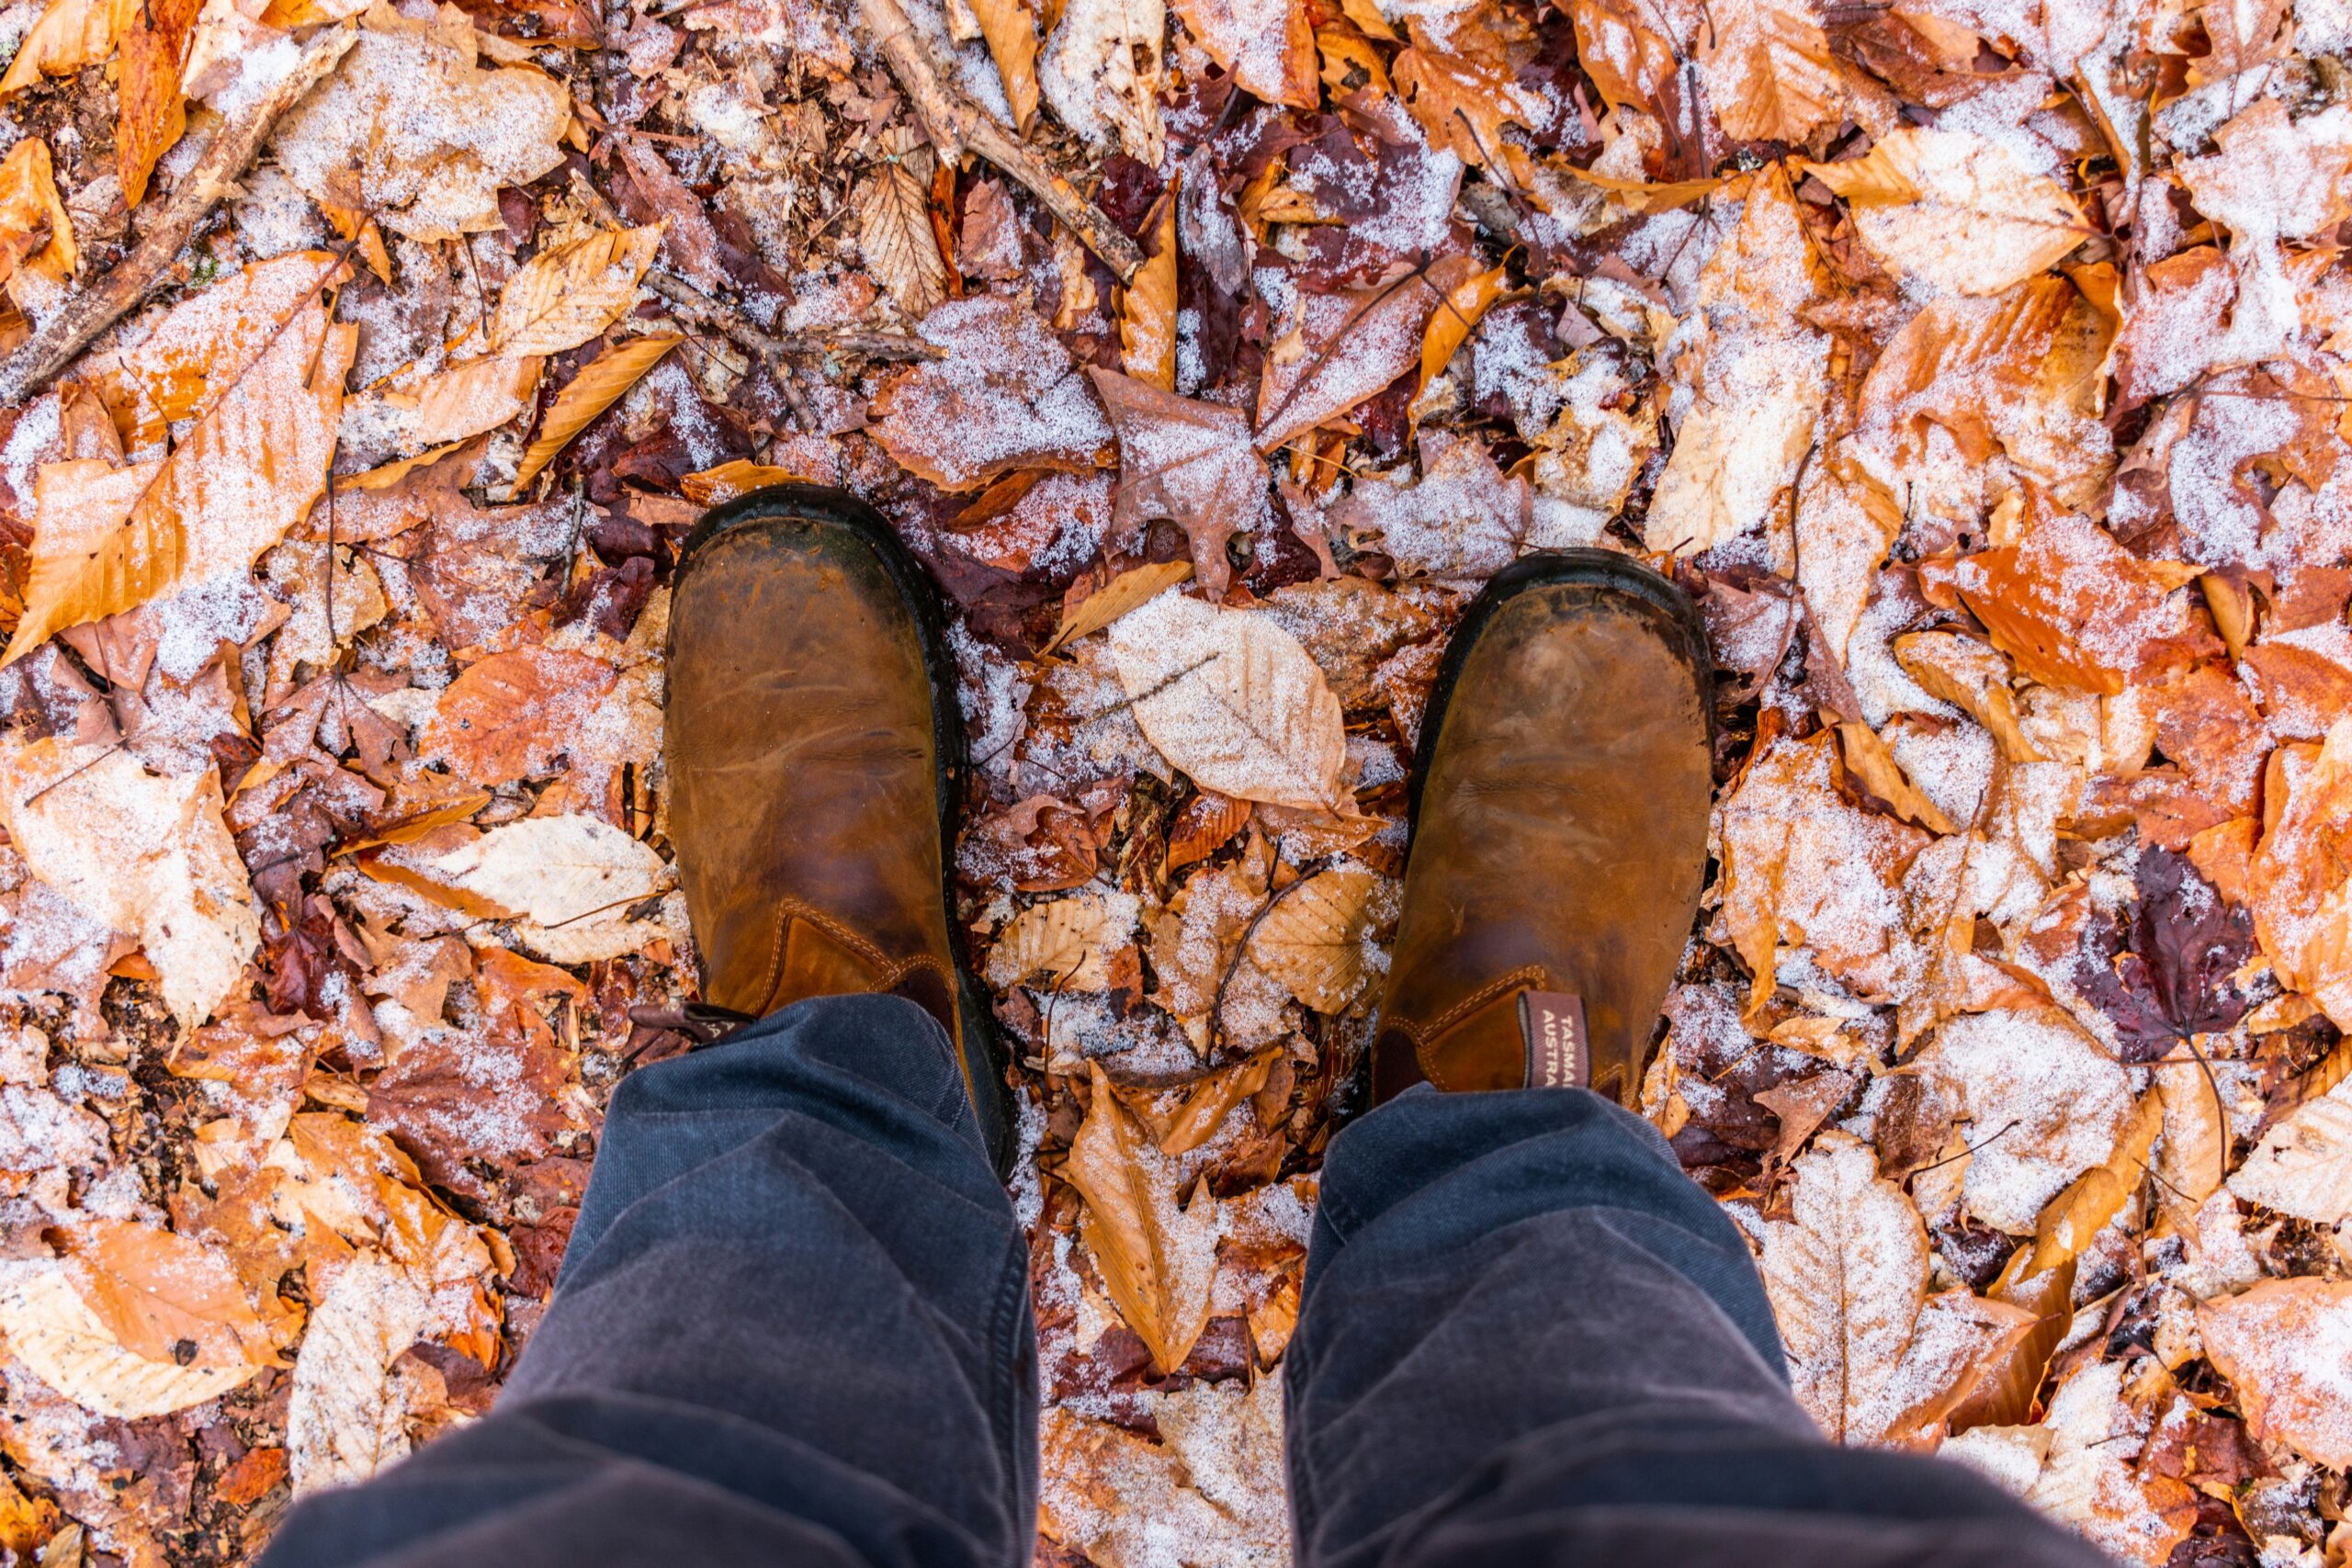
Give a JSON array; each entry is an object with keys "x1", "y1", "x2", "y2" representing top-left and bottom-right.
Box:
[{"x1": 264, "y1": 997, "x2": 2100, "y2": 1568}]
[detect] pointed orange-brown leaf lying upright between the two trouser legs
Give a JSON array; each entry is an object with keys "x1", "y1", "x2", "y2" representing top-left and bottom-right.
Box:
[{"x1": 1063, "y1": 1063, "x2": 1218, "y2": 1373}]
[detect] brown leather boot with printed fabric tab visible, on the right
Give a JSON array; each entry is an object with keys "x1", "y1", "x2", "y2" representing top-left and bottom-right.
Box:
[{"x1": 1371, "y1": 550, "x2": 1713, "y2": 1102}]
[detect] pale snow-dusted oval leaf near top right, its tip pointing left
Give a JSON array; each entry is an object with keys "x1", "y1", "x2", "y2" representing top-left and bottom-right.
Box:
[{"x1": 1804, "y1": 127, "x2": 2091, "y2": 294}]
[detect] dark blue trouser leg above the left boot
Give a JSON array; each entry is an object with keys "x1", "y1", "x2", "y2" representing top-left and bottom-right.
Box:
[{"x1": 266, "y1": 997, "x2": 1037, "y2": 1568}]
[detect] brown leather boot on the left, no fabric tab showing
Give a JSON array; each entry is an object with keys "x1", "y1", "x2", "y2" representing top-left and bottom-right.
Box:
[{"x1": 663, "y1": 484, "x2": 1009, "y2": 1168}]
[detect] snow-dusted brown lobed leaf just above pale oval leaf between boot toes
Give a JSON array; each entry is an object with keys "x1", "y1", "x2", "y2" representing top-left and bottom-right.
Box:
[{"x1": 1086, "y1": 367, "x2": 1272, "y2": 602}]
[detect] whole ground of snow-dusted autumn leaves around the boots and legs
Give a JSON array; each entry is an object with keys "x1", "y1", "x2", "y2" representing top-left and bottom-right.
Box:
[{"x1": 0, "y1": 0, "x2": 2352, "y2": 1568}]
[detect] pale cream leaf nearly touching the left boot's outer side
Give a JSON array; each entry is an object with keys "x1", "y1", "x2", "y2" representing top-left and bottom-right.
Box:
[{"x1": 433, "y1": 813, "x2": 680, "y2": 964}]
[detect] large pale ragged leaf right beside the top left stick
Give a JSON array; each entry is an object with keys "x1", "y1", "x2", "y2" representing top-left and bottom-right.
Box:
[{"x1": 270, "y1": 0, "x2": 571, "y2": 244}]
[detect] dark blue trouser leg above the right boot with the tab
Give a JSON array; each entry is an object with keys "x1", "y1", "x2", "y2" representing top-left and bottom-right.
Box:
[{"x1": 1284, "y1": 1089, "x2": 2103, "y2": 1568}]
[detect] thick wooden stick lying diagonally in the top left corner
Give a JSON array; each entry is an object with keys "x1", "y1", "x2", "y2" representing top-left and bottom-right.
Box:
[{"x1": 0, "y1": 24, "x2": 360, "y2": 404}]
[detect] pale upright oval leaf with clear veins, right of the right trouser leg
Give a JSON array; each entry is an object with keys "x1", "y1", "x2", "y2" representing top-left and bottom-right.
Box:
[{"x1": 1761, "y1": 1131, "x2": 1928, "y2": 1438}]
